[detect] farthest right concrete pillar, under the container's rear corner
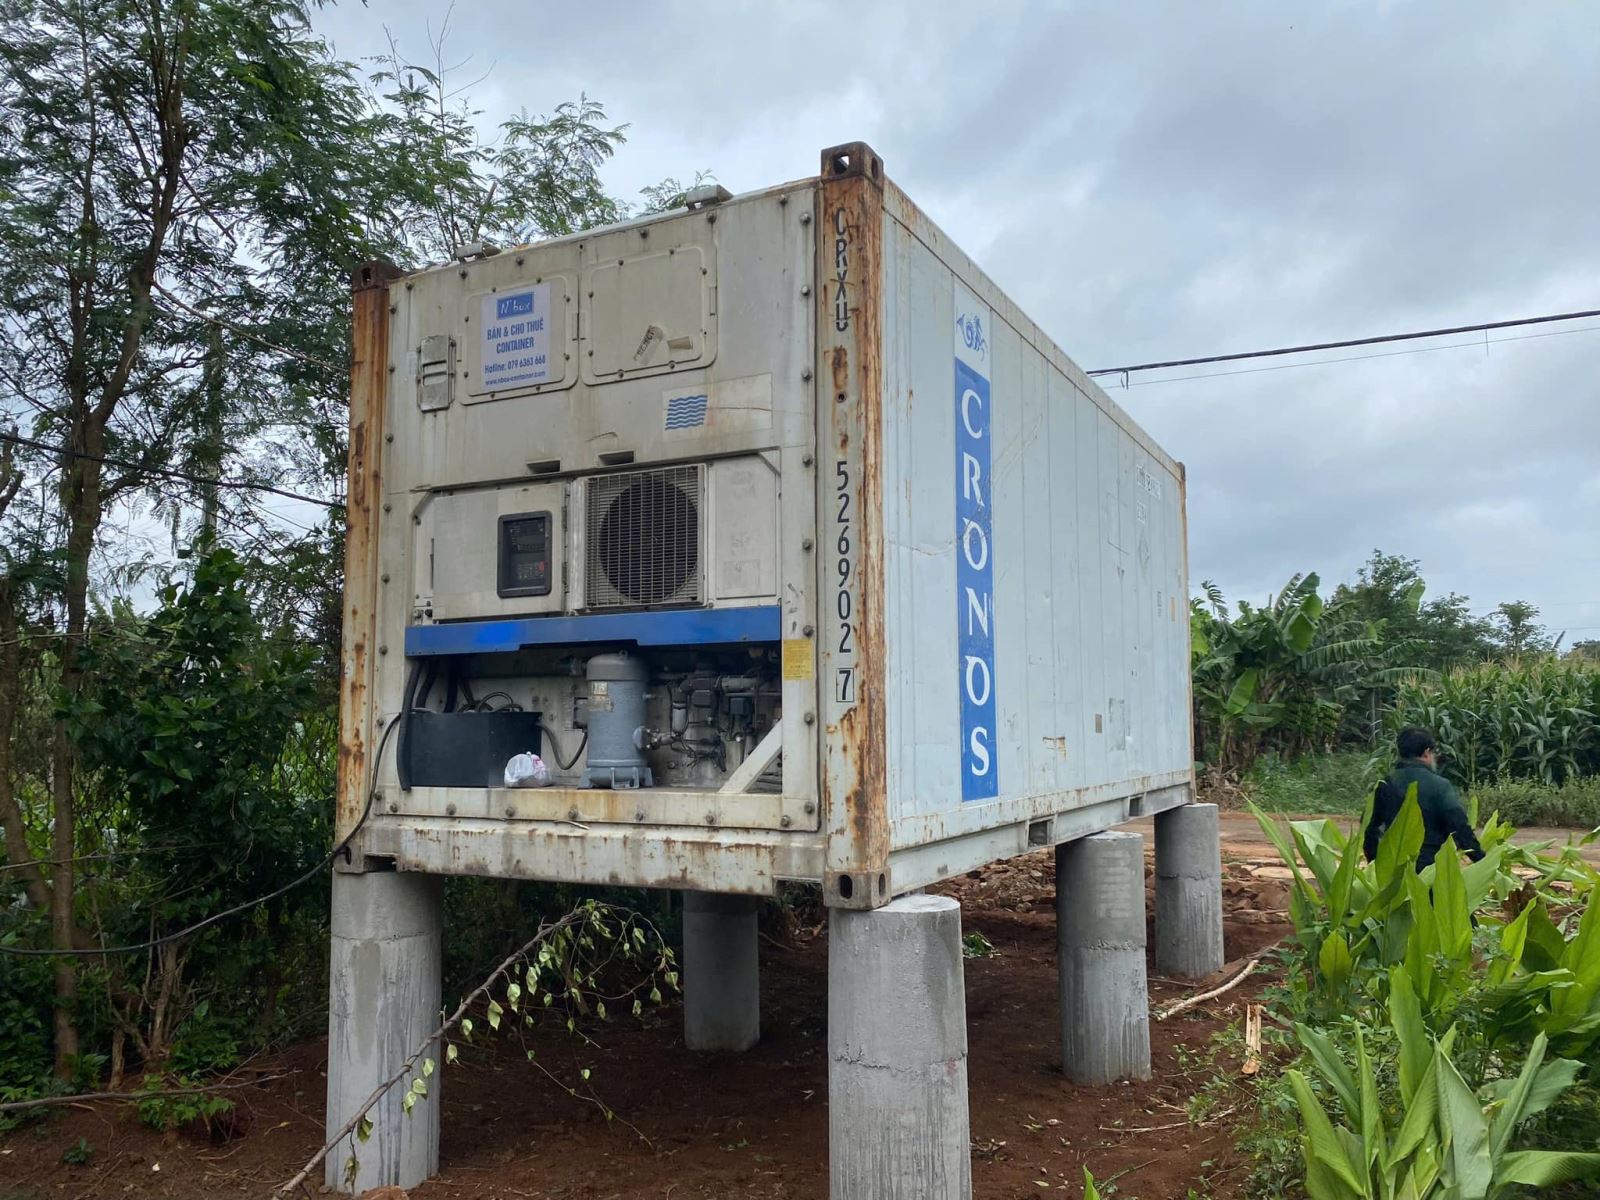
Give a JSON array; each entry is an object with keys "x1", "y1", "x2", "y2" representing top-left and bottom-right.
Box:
[{"x1": 1155, "y1": 805, "x2": 1222, "y2": 979}]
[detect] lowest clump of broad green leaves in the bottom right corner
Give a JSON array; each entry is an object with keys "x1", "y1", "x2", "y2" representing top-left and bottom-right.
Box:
[{"x1": 1286, "y1": 968, "x2": 1600, "y2": 1200}]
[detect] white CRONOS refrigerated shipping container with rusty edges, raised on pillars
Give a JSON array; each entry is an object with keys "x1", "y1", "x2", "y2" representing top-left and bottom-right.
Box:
[{"x1": 339, "y1": 144, "x2": 1192, "y2": 907}]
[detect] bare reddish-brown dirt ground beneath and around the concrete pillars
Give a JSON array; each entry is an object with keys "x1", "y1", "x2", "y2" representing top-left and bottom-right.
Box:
[{"x1": 0, "y1": 851, "x2": 1288, "y2": 1200}]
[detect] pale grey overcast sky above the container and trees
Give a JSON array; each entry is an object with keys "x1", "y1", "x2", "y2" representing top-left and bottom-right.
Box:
[{"x1": 308, "y1": 0, "x2": 1600, "y2": 642}]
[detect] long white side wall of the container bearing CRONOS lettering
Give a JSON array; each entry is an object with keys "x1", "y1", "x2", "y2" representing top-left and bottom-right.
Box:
[{"x1": 883, "y1": 186, "x2": 1192, "y2": 857}]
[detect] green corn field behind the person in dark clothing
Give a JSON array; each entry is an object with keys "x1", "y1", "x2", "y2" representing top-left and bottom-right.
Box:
[{"x1": 1390, "y1": 659, "x2": 1600, "y2": 787}]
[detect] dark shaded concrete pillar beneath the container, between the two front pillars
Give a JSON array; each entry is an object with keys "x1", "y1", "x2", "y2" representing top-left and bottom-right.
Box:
[{"x1": 683, "y1": 891, "x2": 762, "y2": 1051}]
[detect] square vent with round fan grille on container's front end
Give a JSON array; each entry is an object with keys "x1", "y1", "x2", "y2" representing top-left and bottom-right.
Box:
[{"x1": 584, "y1": 466, "x2": 706, "y2": 608}]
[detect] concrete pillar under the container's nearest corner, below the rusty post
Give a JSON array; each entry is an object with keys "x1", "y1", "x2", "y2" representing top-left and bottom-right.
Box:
[{"x1": 827, "y1": 896, "x2": 973, "y2": 1200}]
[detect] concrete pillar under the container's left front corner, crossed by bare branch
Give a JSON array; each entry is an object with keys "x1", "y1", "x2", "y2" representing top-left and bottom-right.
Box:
[{"x1": 325, "y1": 870, "x2": 443, "y2": 1195}]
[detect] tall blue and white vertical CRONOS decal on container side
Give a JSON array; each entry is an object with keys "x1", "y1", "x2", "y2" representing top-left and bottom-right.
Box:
[{"x1": 955, "y1": 285, "x2": 1000, "y2": 803}]
